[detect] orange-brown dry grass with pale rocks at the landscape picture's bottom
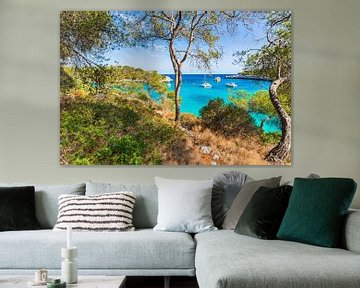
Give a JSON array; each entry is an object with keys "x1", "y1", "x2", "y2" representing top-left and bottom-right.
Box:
[{"x1": 159, "y1": 112, "x2": 272, "y2": 165}]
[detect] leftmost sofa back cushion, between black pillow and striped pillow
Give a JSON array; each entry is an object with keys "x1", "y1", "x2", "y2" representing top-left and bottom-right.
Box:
[{"x1": 0, "y1": 183, "x2": 85, "y2": 229}]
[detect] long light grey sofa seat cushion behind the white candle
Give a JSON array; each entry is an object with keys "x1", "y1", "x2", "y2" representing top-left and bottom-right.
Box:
[{"x1": 0, "y1": 229, "x2": 195, "y2": 270}]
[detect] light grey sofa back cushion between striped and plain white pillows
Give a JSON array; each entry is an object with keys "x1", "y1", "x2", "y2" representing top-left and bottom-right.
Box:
[{"x1": 85, "y1": 181, "x2": 158, "y2": 229}]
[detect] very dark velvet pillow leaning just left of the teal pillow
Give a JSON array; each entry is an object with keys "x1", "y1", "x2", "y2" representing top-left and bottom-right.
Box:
[{"x1": 235, "y1": 185, "x2": 292, "y2": 239}]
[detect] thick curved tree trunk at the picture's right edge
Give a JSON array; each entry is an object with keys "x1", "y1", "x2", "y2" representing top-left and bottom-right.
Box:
[{"x1": 265, "y1": 78, "x2": 291, "y2": 163}]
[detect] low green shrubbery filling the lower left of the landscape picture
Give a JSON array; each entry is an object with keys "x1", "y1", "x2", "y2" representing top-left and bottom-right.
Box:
[{"x1": 60, "y1": 95, "x2": 183, "y2": 165}]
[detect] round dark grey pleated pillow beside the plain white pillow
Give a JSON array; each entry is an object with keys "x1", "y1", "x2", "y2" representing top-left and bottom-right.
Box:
[{"x1": 211, "y1": 171, "x2": 252, "y2": 228}]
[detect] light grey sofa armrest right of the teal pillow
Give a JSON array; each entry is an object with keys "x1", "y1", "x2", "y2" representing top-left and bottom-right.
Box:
[{"x1": 342, "y1": 210, "x2": 360, "y2": 253}]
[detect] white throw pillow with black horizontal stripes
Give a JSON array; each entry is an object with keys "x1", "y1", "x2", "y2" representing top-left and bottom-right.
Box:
[{"x1": 54, "y1": 191, "x2": 135, "y2": 231}]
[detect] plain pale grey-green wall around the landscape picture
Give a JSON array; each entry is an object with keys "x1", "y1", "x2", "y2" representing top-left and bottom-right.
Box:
[{"x1": 0, "y1": 0, "x2": 360, "y2": 207}]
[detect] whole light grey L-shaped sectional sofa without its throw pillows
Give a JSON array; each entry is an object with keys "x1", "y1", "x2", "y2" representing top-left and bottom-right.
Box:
[{"x1": 0, "y1": 182, "x2": 360, "y2": 288}]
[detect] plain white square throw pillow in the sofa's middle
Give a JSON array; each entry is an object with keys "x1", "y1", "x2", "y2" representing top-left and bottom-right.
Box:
[{"x1": 154, "y1": 177, "x2": 217, "y2": 233}]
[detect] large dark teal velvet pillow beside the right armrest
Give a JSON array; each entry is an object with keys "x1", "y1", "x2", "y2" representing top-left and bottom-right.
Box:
[{"x1": 277, "y1": 178, "x2": 356, "y2": 247}]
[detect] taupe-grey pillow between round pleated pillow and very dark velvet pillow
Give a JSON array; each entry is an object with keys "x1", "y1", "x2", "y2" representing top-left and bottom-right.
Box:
[{"x1": 222, "y1": 176, "x2": 281, "y2": 230}]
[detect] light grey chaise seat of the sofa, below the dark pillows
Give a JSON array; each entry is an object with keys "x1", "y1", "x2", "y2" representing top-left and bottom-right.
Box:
[{"x1": 195, "y1": 230, "x2": 360, "y2": 288}]
